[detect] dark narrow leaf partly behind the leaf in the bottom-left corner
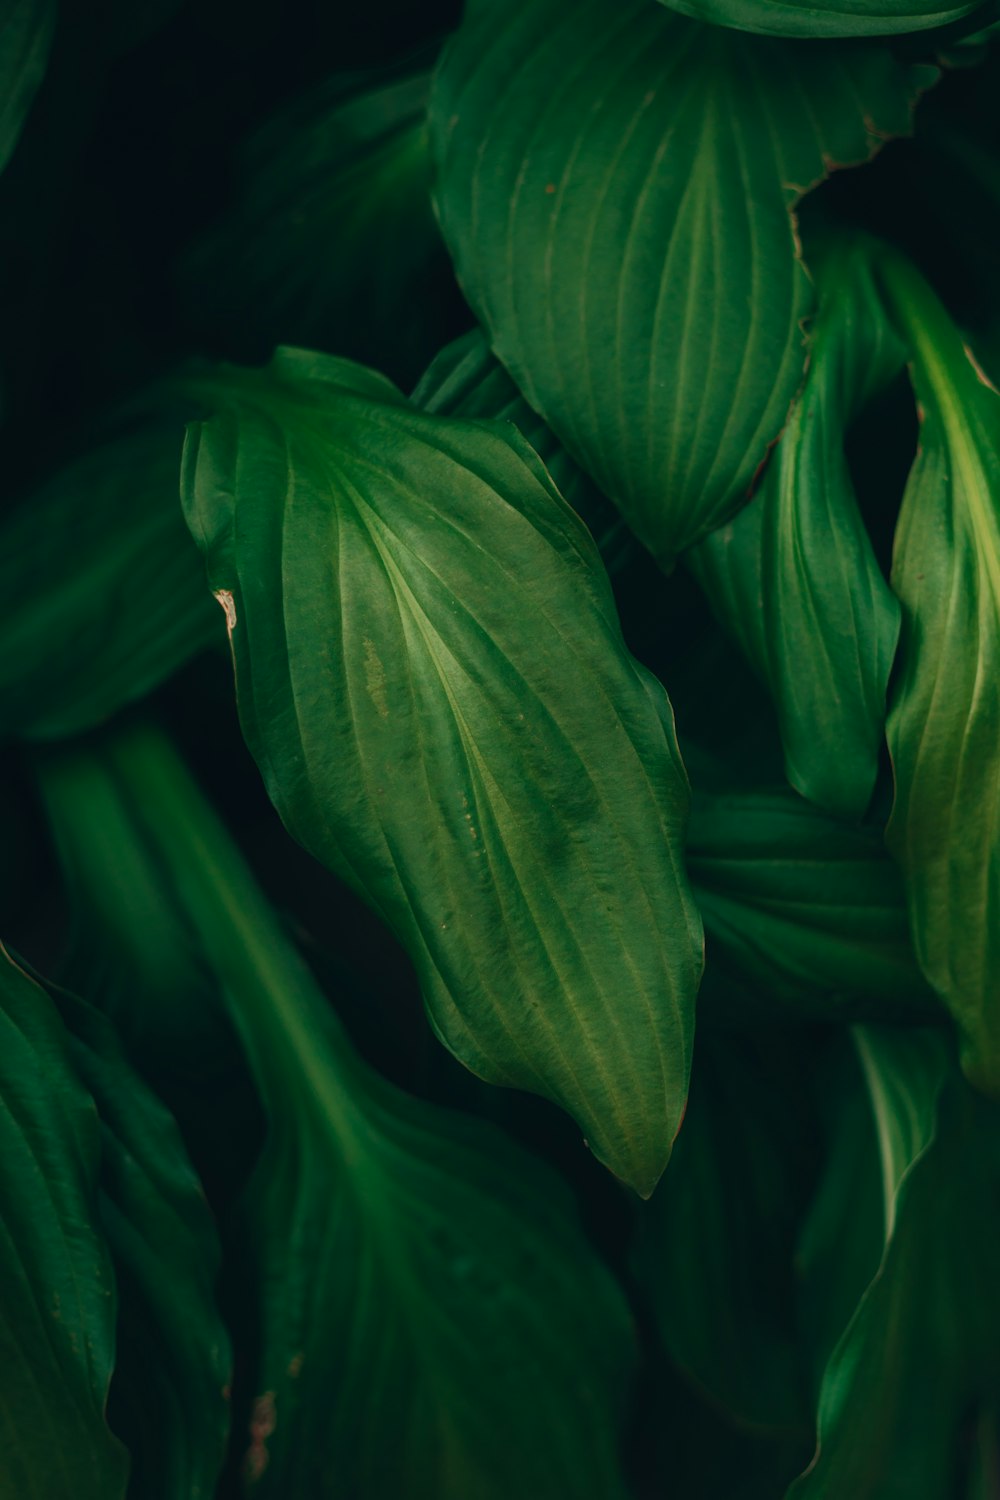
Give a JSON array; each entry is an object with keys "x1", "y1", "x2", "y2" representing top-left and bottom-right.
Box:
[{"x1": 41, "y1": 972, "x2": 231, "y2": 1500}]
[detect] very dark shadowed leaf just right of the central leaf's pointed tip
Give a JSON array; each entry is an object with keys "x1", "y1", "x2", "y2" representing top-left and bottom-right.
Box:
[{"x1": 633, "y1": 1031, "x2": 814, "y2": 1440}]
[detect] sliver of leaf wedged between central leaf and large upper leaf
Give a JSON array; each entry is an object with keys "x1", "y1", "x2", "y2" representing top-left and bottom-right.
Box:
[{"x1": 411, "y1": 329, "x2": 636, "y2": 575}]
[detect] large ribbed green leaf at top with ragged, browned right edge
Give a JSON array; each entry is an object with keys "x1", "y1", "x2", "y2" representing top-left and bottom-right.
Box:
[{"x1": 430, "y1": 0, "x2": 933, "y2": 566}]
